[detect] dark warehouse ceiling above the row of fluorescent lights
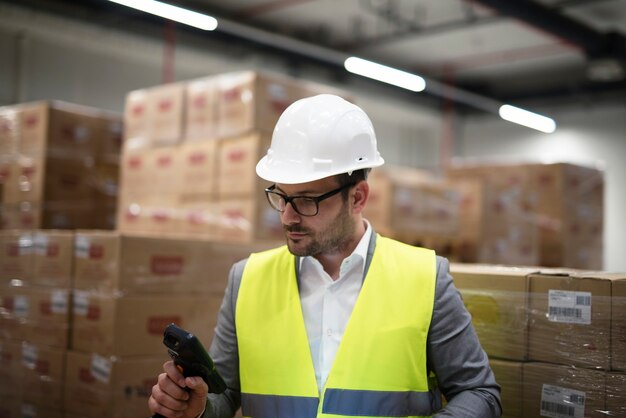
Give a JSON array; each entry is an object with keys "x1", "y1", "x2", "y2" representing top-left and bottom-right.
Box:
[{"x1": 4, "y1": 0, "x2": 626, "y2": 109}]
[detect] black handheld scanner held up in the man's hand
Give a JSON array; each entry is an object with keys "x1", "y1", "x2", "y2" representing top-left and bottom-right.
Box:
[{"x1": 152, "y1": 323, "x2": 226, "y2": 418}]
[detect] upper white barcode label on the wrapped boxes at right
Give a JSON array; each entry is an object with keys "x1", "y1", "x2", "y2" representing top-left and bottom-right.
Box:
[{"x1": 548, "y1": 290, "x2": 591, "y2": 325}]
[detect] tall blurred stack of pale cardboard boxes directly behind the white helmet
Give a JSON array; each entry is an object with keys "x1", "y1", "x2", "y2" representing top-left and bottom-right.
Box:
[{"x1": 118, "y1": 71, "x2": 349, "y2": 242}]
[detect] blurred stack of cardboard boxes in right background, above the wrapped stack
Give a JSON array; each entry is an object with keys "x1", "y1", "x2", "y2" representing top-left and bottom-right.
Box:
[{"x1": 447, "y1": 163, "x2": 604, "y2": 270}]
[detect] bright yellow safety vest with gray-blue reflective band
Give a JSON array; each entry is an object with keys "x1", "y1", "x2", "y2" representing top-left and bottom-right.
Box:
[{"x1": 235, "y1": 236, "x2": 441, "y2": 418}]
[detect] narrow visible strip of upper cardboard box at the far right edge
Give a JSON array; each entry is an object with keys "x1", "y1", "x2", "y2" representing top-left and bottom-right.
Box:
[{"x1": 611, "y1": 274, "x2": 626, "y2": 371}]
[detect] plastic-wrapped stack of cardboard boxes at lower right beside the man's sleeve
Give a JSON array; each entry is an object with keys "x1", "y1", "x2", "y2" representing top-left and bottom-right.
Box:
[{"x1": 451, "y1": 264, "x2": 626, "y2": 418}]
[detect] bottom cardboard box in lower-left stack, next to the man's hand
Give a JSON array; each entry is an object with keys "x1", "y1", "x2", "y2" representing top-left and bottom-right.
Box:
[{"x1": 63, "y1": 351, "x2": 167, "y2": 418}]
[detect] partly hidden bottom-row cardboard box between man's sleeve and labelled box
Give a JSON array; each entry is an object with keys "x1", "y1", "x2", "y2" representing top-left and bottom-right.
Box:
[{"x1": 489, "y1": 359, "x2": 524, "y2": 418}]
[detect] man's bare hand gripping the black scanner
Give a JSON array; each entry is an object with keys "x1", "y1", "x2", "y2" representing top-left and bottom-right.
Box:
[{"x1": 148, "y1": 360, "x2": 209, "y2": 418}]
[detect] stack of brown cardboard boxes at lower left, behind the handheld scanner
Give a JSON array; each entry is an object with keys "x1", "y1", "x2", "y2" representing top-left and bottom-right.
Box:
[{"x1": 0, "y1": 230, "x2": 266, "y2": 418}]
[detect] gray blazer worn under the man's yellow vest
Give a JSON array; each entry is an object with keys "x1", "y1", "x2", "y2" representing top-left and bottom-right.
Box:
[{"x1": 202, "y1": 233, "x2": 502, "y2": 418}]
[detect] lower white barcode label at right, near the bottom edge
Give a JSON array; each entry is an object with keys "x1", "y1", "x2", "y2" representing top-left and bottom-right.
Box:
[{"x1": 540, "y1": 384, "x2": 586, "y2": 418}]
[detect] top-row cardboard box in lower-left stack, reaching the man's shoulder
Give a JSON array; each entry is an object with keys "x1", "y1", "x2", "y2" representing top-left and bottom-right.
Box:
[{"x1": 74, "y1": 230, "x2": 270, "y2": 294}]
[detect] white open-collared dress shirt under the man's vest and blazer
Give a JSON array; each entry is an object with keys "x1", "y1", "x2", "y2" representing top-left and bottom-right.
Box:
[{"x1": 300, "y1": 221, "x2": 372, "y2": 393}]
